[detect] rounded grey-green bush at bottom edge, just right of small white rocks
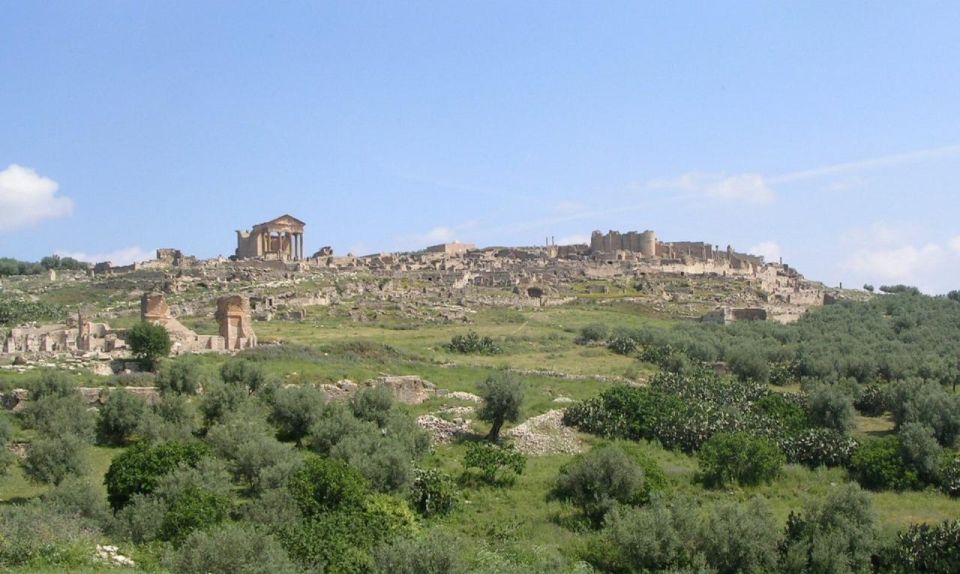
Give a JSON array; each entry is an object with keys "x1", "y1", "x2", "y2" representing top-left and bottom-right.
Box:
[{"x1": 164, "y1": 524, "x2": 300, "y2": 574}]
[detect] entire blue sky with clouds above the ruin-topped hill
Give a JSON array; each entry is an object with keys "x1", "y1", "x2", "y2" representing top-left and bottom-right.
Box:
[{"x1": 0, "y1": 0, "x2": 960, "y2": 292}]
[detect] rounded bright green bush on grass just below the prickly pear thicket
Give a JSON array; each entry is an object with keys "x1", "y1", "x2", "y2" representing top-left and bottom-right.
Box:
[{"x1": 697, "y1": 432, "x2": 785, "y2": 486}]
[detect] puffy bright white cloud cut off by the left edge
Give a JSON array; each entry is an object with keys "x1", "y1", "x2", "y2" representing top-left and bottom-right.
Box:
[{"x1": 0, "y1": 163, "x2": 73, "y2": 232}]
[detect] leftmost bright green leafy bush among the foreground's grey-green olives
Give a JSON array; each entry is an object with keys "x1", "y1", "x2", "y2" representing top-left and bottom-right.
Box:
[{"x1": 104, "y1": 442, "x2": 209, "y2": 510}]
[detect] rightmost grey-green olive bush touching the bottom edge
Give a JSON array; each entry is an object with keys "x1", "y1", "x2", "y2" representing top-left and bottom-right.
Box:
[{"x1": 781, "y1": 484, "x2": 877, "y2": 574}]
